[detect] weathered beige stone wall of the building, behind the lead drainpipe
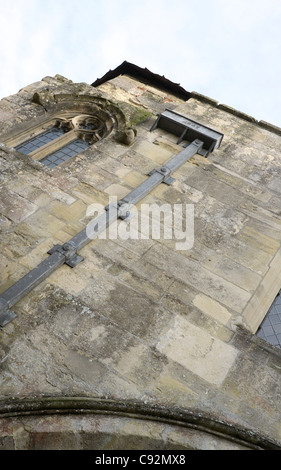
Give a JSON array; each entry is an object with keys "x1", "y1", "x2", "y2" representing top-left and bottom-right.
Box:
[{"x1": 0, "y1": 70, "x2": 281, "y2": 450}]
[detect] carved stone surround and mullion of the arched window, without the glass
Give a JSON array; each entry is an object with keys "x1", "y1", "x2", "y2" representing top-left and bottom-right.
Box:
[{"x1": 0, "y1": 90, "x2": 128, "y2": 166}]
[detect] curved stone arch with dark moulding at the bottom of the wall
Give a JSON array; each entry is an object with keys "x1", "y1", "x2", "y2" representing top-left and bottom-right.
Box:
[{"x1": 0, "y1": 397, "x2": 280, "y2": 450}]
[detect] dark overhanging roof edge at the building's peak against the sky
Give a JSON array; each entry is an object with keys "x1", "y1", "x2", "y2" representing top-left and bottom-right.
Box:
[{"x1": 91, "y1": 60, "x2": 191, "y2": 101}]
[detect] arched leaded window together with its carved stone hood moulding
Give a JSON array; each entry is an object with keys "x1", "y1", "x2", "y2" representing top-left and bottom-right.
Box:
[{"x1": 3, "y1": 89, "x2": 129, "y2": 161}]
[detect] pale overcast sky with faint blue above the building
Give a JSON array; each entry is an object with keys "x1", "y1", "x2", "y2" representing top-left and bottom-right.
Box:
[{"x1": 0, "y1": 0, "x2": 281, "y2": 127}]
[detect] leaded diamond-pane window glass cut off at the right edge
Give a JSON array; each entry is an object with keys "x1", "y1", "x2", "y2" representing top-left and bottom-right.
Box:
[{"x1": 257, "y1": 291, "x2": 281, "y2": 348}]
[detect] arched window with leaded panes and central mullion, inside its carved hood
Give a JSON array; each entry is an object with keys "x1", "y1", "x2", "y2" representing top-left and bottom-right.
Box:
[{"x1": 15, "y1": 114, "x2": 107, "y2": 168}]
